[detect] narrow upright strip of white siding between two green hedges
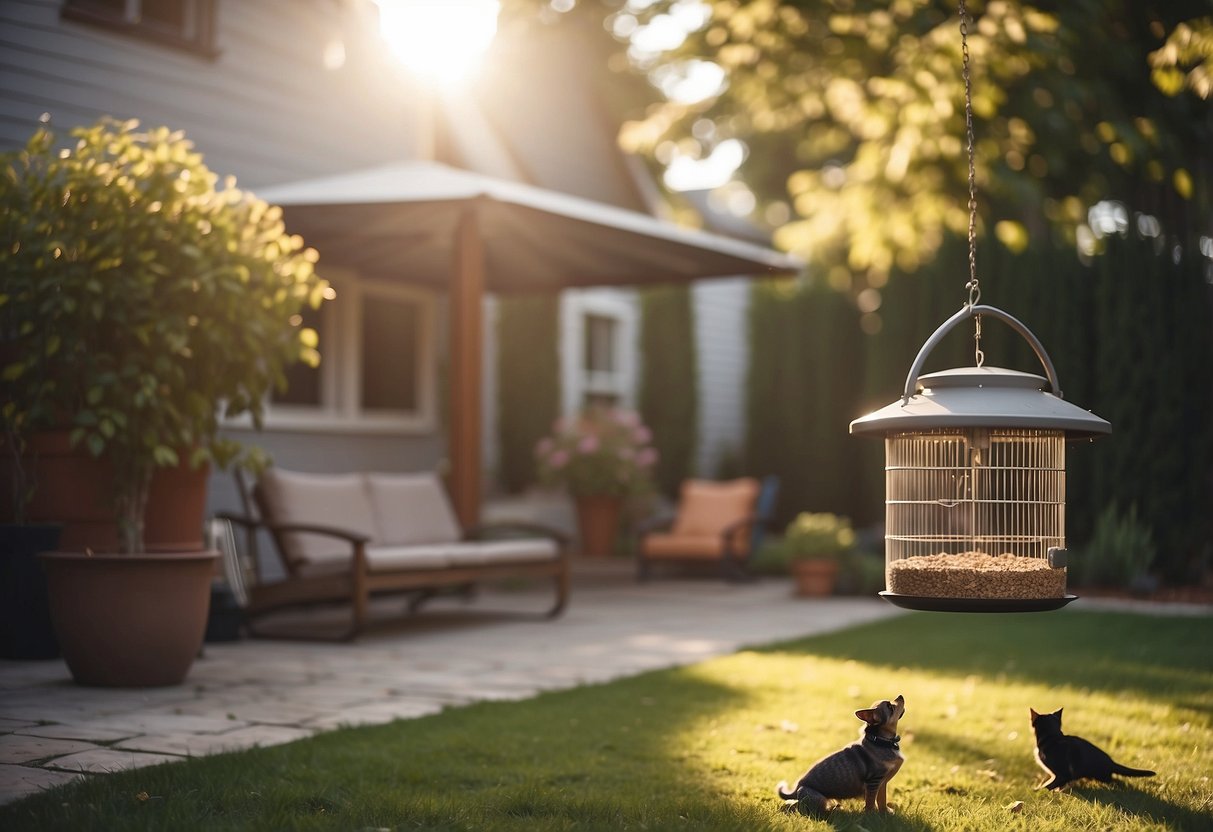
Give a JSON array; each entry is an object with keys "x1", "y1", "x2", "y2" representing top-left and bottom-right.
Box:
[{"x1": 691, "y1": 278, "x2": 750, "y2": 478}]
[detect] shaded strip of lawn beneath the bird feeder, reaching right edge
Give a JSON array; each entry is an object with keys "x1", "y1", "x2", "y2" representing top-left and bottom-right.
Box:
[{"x1": 765, "y1": 611, "x2": 1213, "y2": 710}]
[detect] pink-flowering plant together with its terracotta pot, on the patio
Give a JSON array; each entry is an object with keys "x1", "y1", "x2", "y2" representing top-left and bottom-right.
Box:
[{"x1": 535, "y1": 408, "x2": 657, "y2": 555}]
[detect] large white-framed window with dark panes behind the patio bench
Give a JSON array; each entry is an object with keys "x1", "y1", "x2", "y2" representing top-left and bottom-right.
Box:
[{"x1": 258, "y1": 280, "x2": 437, "y2": 433}]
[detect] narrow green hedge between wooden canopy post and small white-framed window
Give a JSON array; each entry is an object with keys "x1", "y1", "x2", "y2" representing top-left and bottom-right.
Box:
[{"x1": 497, "y1": 295, "x2": 560, "y2": 492}]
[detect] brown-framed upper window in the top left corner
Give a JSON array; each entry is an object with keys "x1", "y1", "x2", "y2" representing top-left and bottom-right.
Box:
[{"x1": 63, "y1": 0, "x2": 215, "y2": 56}]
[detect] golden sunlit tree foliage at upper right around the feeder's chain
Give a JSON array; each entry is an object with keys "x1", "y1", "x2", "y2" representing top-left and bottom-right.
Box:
[{"x1": 623, "y1": 0, "x2": 1213, "y2": 290}]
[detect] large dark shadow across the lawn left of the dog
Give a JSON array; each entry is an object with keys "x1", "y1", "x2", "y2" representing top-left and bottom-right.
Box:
[{"x1": 0, "y1": 672, "x2": 800, "y2": 832}]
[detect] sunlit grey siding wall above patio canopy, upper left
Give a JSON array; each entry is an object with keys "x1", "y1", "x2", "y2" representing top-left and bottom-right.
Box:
[{"x1": 0, "y1": 0, "x2": 422, "y2": 188}]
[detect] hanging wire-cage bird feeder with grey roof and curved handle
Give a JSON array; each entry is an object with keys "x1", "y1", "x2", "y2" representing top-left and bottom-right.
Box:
[{"x1": 850, "y1": 303, "x2": 1111, "y2": 612}]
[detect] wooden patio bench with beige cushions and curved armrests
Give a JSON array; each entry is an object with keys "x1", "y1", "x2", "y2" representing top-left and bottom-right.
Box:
[{"x1": 218, "y1": 468, "x2": 569, "y2": 639}]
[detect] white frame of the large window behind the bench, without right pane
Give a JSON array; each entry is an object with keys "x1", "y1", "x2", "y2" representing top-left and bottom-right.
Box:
[{"x1": 228, "y1": 268, "x2": 438, "y2": 433}]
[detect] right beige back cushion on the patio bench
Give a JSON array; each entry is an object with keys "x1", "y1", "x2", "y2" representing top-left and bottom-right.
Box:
[{"x1": 366, "y1": 473, "x2": 463, "y2": 546}]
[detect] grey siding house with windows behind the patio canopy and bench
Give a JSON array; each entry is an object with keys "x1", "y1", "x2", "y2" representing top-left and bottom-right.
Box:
[{"x1": 0, "y1": 0, "x2": 776, "y2": 560}]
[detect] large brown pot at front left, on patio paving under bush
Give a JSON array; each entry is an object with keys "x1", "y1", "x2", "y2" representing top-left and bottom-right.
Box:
[{"x1": 40, "y1": 549, "x2": 220, "y2": 688}]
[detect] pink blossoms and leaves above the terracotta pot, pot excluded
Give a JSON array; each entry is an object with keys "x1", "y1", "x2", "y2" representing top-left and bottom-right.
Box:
[{"x1": 535, "y1": 408, "x2": 657, "y2": 496}]
